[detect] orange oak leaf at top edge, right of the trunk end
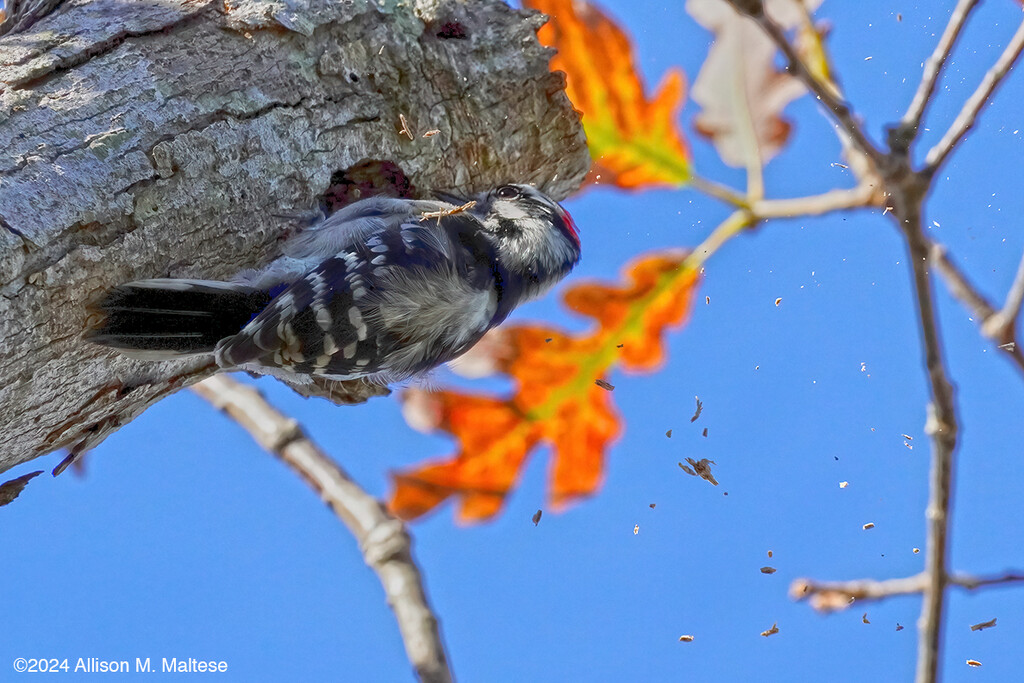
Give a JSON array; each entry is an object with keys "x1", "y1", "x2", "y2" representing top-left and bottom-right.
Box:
[{"x1": 523, "y1": 0, "x2": 691, "y2": 188}]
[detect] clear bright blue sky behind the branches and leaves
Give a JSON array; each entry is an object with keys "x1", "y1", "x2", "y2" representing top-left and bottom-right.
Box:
[{"x1": 0, "y1": 0, "x2": 1024, "y2": 681}]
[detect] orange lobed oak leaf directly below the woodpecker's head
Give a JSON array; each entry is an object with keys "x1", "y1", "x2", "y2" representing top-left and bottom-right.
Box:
[{"x1": 389, "y1": 252, "x2": 697, "y2": 521}]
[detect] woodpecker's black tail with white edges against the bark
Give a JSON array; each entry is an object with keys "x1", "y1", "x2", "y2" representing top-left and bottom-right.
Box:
[{"x1": 85, "y1": 280, "x2": 270, "y2": 359}]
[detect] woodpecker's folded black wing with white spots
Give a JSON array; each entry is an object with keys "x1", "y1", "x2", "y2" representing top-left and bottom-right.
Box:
[{"x1": 216, "y1": 210, "x2": 500, "y2": 382}]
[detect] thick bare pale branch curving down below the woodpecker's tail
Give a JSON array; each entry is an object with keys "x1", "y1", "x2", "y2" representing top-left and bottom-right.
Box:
[{"x1": 193, "y1": 375, "x2": 452, "y2": 683}]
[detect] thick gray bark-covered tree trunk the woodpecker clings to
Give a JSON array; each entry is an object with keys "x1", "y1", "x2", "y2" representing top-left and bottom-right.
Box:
[{"x1": 0, "y1": 0, "x2": 590, "y2": 472}]
